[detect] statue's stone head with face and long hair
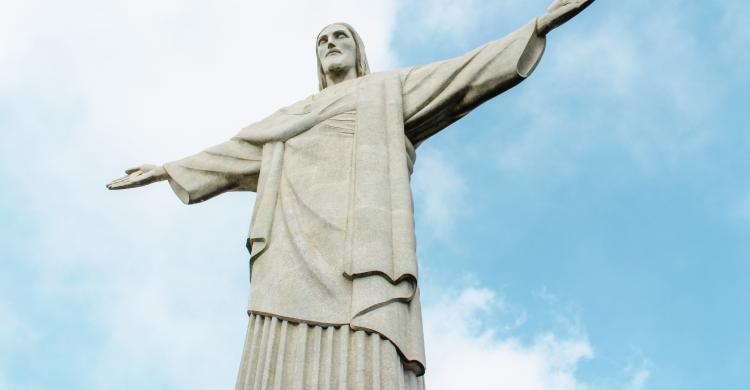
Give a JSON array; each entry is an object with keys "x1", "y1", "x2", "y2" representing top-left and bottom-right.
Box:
[{"x1": 315, "y1": 23, "x2": 370, "y2": 91}]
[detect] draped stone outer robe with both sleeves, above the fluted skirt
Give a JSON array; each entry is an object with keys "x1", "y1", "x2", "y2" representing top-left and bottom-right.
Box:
[{"x1": 165, "y1": 21, "x2": 545, "y2": 375}]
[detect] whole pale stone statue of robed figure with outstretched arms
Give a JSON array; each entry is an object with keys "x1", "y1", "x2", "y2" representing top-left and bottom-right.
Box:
[{"x1": 107, "y1": 0, "x2": 593, "y2": 390}]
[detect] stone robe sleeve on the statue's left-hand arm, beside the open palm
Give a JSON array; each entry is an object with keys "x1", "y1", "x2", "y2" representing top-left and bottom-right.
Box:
[{"x1": 164, "y1": 137, "x2": 262, "y2": 204}]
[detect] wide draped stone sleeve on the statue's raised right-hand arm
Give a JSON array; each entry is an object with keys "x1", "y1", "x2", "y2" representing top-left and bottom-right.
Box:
[{"x1": 401, "y1": 20, "x2": 545, "y2": 145}]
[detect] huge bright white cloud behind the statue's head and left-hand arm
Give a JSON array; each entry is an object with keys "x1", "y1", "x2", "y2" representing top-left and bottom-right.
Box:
[{"x1": 0, "y1": 0, "x2": 395, "y2": 389}]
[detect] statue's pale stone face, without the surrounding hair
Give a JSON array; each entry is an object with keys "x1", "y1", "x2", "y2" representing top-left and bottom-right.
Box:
[{"x1": 318, "y1": 24, "x2": 357, "y2": 77}]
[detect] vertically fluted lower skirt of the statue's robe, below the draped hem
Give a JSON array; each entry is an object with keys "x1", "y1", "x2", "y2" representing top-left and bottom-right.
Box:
[{"x1": 235, "y1": 314, "x2": 424, "y2": 390}]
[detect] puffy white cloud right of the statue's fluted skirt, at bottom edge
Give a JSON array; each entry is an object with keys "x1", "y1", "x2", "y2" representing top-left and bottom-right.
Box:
[{"x1": 424, "y1": 287, "x2": 594, "y2": 390}]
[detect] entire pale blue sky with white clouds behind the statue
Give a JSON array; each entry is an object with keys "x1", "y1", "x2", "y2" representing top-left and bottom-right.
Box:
[{"x1": 0, "y1": 0, "x2": 750, "y2": 390}]
